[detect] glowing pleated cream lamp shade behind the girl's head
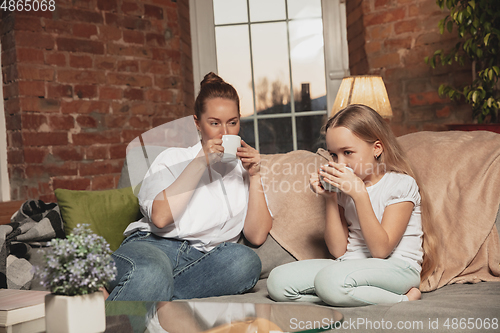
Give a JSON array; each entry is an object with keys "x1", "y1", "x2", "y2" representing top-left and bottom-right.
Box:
[{"x1": 331, "y1": 75, "x2": 392, "y2": 118}]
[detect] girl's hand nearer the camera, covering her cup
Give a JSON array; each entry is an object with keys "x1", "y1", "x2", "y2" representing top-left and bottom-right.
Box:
[{"x1": 319, "y1": 162, "x2": 366, "y2": 197}]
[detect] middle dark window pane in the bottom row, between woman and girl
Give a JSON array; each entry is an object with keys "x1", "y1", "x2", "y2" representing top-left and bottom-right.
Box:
[{"x1": 258, "y1": 117, "x2": 293, "y2": 154}]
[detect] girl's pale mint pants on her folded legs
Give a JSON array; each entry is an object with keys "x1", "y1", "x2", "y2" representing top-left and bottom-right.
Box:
[{"x1": 267, "y1": 258, "x2": 420, "y2": 306}]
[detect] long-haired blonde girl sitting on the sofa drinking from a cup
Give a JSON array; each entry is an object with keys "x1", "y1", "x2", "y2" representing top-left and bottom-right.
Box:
[{"x1": 267, "y1": 105, "x2": 433, "y2": 306}]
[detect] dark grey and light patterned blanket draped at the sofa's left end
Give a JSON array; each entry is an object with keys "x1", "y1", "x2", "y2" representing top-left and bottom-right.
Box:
[{"x1": 0, "y1": 200, "x2": 65, "y2": 289}]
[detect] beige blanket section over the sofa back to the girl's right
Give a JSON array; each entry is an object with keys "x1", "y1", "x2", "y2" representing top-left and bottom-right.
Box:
[{"x1": 398, "y1": 131, "x2": 500, "y2": 291}]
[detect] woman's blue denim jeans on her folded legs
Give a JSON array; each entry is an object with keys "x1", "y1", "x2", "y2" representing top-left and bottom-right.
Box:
[{"x1": 108, "y1": 231, "x2": 261, "y2": 301}]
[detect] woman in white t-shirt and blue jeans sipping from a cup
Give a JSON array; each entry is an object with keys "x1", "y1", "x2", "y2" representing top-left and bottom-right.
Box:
[{"x1": 108, "y1": 73, "x2": 272, "y2": 301}]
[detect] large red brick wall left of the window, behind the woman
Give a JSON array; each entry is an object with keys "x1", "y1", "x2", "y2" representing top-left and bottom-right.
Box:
[{"x1": 0, "y1": 0, "x2": 194, "y2": 201}]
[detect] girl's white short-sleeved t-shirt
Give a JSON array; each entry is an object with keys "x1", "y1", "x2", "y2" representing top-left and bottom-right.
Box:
[{"x1": 338, "y1": 172, "x2": 423, "y2": 272}]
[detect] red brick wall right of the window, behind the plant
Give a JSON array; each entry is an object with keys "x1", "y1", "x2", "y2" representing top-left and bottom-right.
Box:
[{"x1": 347, "y1": 0, "x2": 472, "y2": 135}]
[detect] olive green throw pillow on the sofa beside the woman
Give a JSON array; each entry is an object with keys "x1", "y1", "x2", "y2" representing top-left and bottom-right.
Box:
[{"x1": 54, "y1": 187, "x2": 142, "y2": 251}]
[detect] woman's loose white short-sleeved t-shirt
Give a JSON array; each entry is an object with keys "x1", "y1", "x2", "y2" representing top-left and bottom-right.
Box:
[{"x1": 124, "y1": 142, "x2": 249, "y2": 252}]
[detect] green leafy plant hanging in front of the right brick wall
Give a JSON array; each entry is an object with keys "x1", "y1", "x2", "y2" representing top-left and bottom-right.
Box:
[{"x1": 425, "y1": 0, "x2": 500, "y2": 127}]
